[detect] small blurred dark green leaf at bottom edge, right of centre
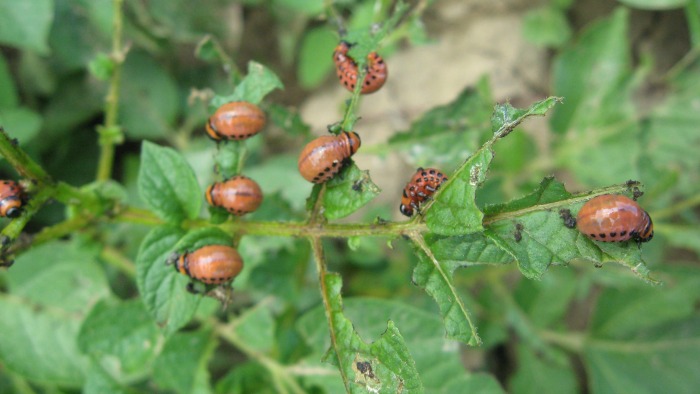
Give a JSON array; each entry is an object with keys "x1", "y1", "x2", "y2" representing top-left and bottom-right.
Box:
[{"x1": 509, "y1": 344, "x2": 579, "y2": 393}]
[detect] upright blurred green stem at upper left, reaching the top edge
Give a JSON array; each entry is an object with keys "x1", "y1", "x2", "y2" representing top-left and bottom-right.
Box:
[{"x1": 97, "y1": 0, "x2": 125, "y2": 181}]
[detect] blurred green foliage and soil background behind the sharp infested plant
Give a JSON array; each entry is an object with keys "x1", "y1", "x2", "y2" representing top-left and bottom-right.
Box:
[{"x1": 0, "y1": 0, "x2": 700, "y2": 393}]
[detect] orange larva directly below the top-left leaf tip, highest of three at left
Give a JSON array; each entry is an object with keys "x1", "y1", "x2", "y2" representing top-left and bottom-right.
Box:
[{"x1": 206, "y1": 101, "x2": 266, "y2": 141}]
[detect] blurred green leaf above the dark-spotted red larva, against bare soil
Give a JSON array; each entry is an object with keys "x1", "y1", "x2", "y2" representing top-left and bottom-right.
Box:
[{"x1": 388, "y1": 78, "x2": 493, "y2": 167}]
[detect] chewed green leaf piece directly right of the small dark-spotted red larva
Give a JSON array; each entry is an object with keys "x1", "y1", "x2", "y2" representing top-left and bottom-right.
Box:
[{"x1": 424, "y1": 146, "x2": 493, "y2": 235}]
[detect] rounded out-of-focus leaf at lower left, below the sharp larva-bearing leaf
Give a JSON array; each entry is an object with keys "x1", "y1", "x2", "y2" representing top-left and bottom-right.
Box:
[{"x1": 78, "y1": 300, "x2": 159, "y2": 377}]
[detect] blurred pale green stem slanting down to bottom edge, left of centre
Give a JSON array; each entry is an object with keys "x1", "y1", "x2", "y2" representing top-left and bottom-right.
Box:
[{"x1": 215, "y1": 319, "x2": 305, "y2": 394}]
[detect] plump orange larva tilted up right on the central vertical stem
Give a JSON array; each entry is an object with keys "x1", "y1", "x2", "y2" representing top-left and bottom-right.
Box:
[{"x1": 297, "y1": 131, "x2": 361, "y2": 183}]
